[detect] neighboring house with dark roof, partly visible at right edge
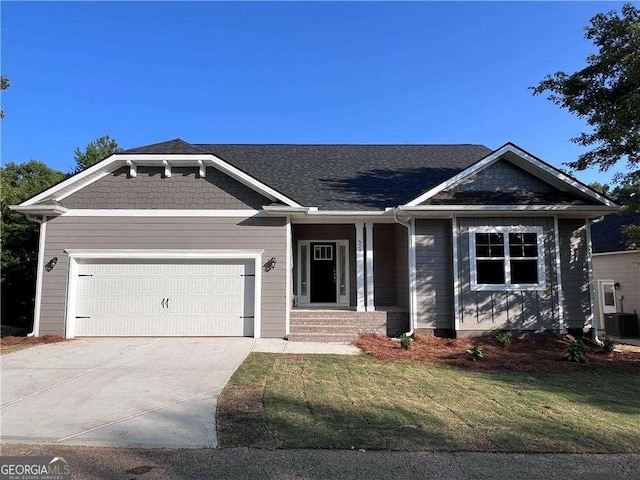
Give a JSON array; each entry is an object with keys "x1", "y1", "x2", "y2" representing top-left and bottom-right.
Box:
[{"x1": 593, "y1": 213, "x2": 640, "y2": 333}]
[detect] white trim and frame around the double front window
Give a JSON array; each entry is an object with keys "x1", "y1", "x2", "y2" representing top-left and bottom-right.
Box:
[{"x1": 469, "y1": 226, "x2": 546, "y2": 292}]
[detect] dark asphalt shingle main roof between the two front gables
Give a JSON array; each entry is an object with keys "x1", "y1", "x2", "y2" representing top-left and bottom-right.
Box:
[{"x1": 124, "y1": 139, "x2": 491, "y2": 210}]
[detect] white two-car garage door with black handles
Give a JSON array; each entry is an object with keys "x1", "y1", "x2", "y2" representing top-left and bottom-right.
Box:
[{"x1": 74, "y1": 259, "x2": 255, "y2": 336}]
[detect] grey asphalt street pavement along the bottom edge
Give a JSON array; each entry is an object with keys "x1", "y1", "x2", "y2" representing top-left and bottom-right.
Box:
[{"x1": 2, "y1": 444, "x2": 640, "y2": 480}]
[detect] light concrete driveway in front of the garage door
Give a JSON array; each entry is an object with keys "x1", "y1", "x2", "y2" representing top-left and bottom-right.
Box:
[{"x1": 0, "y1": 338, "x2": 255, "y2": 447}]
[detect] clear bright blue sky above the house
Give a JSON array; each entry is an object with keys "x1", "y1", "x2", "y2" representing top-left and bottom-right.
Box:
[{"x1": 1, "y1": 1, "x2": 622, "y2": 182}]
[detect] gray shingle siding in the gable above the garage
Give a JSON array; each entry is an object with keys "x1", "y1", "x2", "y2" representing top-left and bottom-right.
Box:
[{"x1": 60, "y1": 167, "x2": 271, "y2": 210}]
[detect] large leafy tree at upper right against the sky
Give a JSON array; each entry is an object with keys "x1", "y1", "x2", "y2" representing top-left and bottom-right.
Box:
[{"x1": 531, "y1": 4, "x2": 640, "y2": 186}]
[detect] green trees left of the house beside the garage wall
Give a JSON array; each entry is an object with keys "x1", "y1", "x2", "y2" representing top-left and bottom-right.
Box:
[{"x1": 0, "y1": 160, "x2": 66, "y2": 329}]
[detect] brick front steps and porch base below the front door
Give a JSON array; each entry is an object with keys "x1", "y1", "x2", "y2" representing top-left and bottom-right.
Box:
[{"x1": 288, "y1": 309, "x2": 409, "y2": 343}]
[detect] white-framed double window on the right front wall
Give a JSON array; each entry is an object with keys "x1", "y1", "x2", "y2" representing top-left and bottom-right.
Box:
[{"x1": 469, "y1": 226, "x2": 545, "y2": 291}]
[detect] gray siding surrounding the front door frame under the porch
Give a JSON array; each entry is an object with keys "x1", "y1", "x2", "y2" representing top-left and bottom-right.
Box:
[{"x1": 293, "y1": 224, "x2": 358, "y2": 307}]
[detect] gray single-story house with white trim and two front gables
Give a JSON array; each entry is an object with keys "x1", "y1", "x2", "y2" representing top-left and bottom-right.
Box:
[{"x1": 14, "y1": 140, "x2": 620, "y2": 340}]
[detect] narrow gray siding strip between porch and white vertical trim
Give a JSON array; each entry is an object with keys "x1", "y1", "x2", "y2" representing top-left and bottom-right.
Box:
[{"x1": 416, "y1": 220, "x2": 453, "y2": 328}]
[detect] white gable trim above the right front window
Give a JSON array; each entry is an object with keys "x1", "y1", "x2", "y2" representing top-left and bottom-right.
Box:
[{"x1": 406, "y1": 143, "x2": 617, "y2": 207}]
